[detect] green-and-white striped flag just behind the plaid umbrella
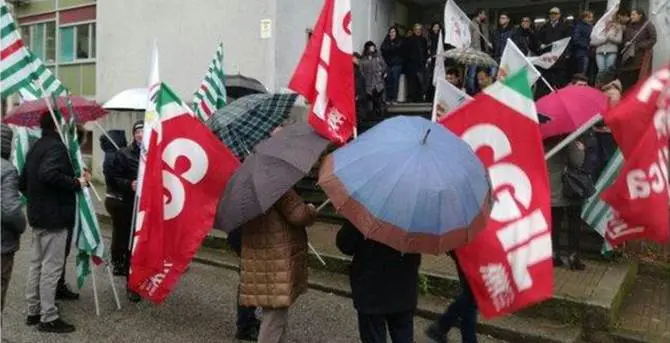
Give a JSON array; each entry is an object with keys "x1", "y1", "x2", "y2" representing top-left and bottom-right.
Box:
[{"x1": 193, "y1": 43, "x2": 226, "y2": 121}]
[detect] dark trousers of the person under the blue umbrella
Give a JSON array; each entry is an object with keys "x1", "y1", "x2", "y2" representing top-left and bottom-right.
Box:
[{"x1": 358, "y1": 311, "x2": 414, "y2": 343}]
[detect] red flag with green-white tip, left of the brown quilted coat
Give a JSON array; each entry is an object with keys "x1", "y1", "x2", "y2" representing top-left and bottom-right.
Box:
[{"x1": 128, "y1": 84, "x2": 239, "y2": 303}]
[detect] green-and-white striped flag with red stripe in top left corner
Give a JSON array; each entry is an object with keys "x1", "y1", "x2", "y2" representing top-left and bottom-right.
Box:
[{"x1": 0, "y1": 0, "x2": 65, "y2": 98}]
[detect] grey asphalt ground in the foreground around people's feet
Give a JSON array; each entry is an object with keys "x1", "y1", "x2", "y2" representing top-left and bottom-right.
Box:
[{"x1": 2, "y1": 233, "x2": 501, "y2": 343}]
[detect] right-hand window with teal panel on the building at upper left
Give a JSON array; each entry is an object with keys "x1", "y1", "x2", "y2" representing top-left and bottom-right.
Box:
[{"x1": 59, "y1": 23, "x2": 95, "y2": 62}]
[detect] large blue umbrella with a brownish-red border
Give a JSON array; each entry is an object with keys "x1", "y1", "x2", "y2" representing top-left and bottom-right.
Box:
[{"x1": 319, "y1": 116, "x2": 491, "y2": 254}]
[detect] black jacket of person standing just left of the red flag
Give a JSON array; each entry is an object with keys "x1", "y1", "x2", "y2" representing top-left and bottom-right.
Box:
[{"x1": 104, "y1": 142, "x2": 140, "y2": 202}]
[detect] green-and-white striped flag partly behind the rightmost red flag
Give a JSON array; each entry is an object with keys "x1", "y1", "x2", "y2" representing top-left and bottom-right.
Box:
[{"x1": 582, "y1": 150, "x2": 623, "y2": 254}]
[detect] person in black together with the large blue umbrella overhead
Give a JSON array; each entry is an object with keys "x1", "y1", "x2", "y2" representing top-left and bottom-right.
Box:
[{"x1": 319, "y1": 116, "x2": 491, "y2": 343}]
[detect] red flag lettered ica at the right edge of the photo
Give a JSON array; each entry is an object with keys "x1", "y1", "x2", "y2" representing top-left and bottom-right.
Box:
[{"x1": 602, "y1": 67, "x2": 670, "y2": 245}]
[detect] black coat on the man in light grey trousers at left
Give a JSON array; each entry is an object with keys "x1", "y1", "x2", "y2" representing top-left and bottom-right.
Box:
[{"x1": 19, "y1": 131, "x2": 81, "y2": 230}]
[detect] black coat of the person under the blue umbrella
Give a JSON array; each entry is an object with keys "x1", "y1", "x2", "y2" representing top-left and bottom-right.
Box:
[{"x1": 337, "y1": 222, "x2": 421, "y2": 314}]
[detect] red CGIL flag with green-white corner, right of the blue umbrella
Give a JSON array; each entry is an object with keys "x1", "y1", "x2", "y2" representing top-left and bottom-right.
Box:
[{"x1": 440, "y1": 71, "x2": 553, "y2": 318}]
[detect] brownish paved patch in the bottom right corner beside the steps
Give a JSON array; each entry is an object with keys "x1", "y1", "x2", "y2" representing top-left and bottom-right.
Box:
[{"x1": 617, "y1": 274, "x2": 670, "y2": 342}]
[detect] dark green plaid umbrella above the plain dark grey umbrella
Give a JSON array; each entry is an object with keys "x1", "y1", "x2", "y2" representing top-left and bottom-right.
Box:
[{"x1": 207, "y1": 94, "x2": 298, "y2": 158}]
